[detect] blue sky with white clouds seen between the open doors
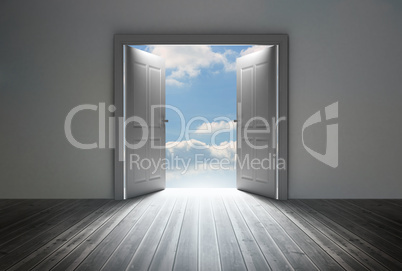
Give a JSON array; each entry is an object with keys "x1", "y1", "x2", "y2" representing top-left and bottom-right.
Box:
[{"x1": 132, "y1": 45, "x2": 263, "y2": 187}]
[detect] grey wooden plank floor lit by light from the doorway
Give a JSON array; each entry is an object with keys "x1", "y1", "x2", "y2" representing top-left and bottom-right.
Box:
[{"x1": 0, "y1": 189, "x2": 402, "y2": 271}]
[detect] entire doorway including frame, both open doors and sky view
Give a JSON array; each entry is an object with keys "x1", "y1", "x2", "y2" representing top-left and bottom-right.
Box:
[{"x1": 115, "y1": 35, "x2": 287, "y2": 199}]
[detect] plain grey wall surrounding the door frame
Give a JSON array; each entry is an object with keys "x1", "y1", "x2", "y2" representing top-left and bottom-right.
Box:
[{"x1": 0, "y1": 0, "x2": 402, "y2": 198}]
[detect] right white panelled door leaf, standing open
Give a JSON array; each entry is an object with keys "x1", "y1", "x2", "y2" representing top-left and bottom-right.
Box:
[{"x1": 237, "y1": 46, "x2": 277, "y2": 198}]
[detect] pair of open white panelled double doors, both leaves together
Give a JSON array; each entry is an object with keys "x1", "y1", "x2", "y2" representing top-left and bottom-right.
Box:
[{"x1": 123, "y1": 45, "x2": 278, "y2": 198}]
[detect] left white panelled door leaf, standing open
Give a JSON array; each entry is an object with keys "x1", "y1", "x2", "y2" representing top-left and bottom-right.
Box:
[{"x1": 124, "y1": 46, "x2": 165, "y2": 198}]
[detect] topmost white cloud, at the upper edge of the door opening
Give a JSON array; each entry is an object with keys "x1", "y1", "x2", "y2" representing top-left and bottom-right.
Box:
[{"x1": 148, "y1": 45, "x2": 236, "y2": 81}]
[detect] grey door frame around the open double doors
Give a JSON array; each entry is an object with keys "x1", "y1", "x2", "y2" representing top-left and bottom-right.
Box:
[{"x1": 114, "y1": 34, "x2": 289, "y2": 200}]
